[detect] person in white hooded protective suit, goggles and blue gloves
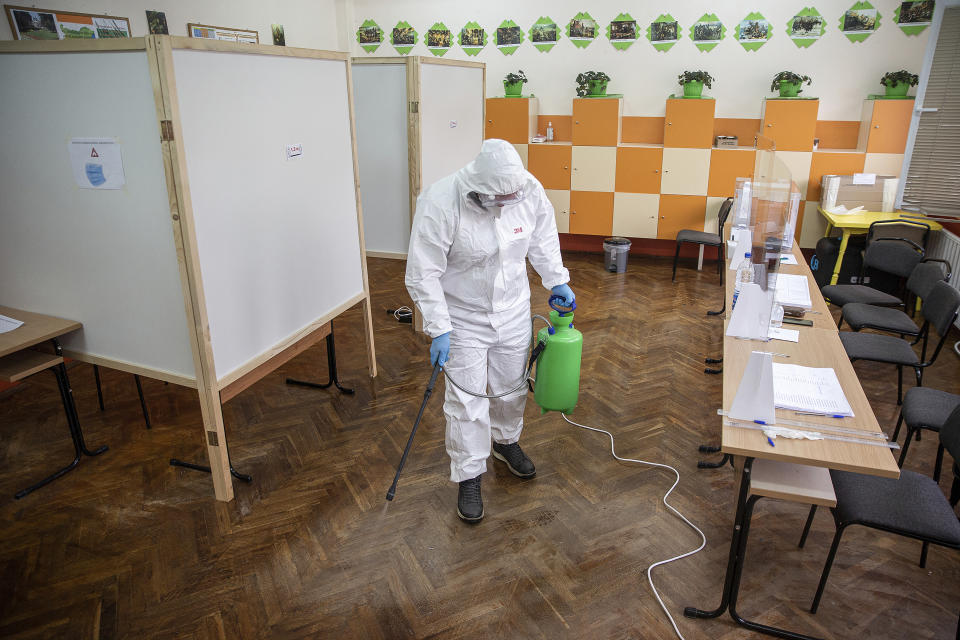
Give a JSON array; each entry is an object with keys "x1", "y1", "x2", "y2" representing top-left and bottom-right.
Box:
[{"x1": 406, "y1": 140, "x2": 574, "y2": 522}]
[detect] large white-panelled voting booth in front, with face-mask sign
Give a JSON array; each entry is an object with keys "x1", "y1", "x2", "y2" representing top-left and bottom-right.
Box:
[{"x1": 0, "y1": 36, "x2": 376, "y2": 500}]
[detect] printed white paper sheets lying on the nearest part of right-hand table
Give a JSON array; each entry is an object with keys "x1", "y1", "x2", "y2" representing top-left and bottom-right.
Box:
[{"x1": 773, "y1": 362, "x2": 853, "y2": 417}]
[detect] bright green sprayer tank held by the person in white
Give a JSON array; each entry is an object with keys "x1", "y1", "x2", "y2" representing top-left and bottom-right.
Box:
[{"x1": 533, "y1": 298, "x2": 583, "y2": 413}]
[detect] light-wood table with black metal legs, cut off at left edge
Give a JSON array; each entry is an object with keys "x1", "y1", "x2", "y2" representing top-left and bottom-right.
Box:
[{"x1": 0, "y1": 306, "x2": 107, "y2": 499}]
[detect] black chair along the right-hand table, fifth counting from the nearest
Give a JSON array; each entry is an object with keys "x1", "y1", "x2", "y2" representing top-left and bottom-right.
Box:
[{"x1": 820, "y1": 238, "x2": 923, "y2": 307}]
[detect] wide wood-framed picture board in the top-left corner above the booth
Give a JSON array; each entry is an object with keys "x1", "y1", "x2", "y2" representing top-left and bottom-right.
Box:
[{"x1": 3, "y1": 4, "x2": 131, "y2": 40}]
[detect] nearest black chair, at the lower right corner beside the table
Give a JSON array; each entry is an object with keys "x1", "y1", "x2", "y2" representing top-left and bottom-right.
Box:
[{"x1": 800, "y1": 408, "x2": 960, "y2": 613}]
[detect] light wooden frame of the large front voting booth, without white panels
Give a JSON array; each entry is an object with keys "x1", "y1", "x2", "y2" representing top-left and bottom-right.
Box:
[{"x1": 0, "y1": 35, "x2": 377, "y2": 501}]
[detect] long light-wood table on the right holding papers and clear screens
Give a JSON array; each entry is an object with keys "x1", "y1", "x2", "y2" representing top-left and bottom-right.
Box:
[{"x1": 684, "y1": 240, "x2": 900, "y2": 639}]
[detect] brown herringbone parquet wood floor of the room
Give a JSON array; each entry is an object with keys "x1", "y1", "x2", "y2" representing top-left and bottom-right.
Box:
[{"x1": 0, "y1": 254, "x2": 960, "y2": 640}]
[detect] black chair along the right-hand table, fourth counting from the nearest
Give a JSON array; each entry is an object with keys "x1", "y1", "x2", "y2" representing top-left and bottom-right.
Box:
[{"x1": 837, "y1": 258, "x2": 952, "y2": 337}]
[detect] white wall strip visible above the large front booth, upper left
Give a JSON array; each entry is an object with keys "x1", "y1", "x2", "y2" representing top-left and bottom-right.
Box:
[{"x1": 0, "y1": 0, "x2": 342, "y2": 50}]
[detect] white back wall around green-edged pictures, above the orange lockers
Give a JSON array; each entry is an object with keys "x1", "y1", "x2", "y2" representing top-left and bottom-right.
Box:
[{"x1": 350, "y1": 0, "x2": 929, "y2": 120}]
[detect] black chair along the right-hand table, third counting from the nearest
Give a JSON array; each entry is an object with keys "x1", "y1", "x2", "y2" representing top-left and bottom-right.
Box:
[{"x1": 840, "y1": 282, "x2": 960, "y2": 404}]
